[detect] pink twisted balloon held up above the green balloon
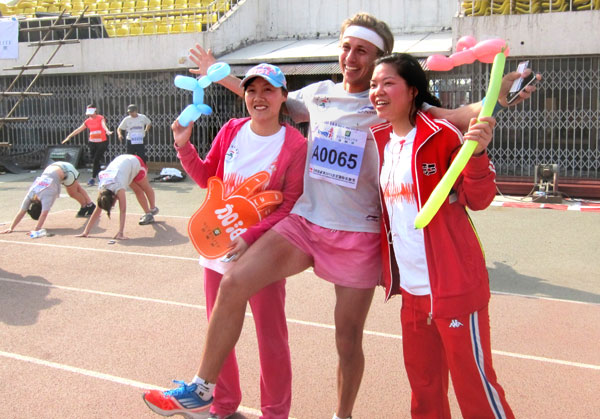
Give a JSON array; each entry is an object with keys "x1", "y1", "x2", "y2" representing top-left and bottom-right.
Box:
[{"x1": 427, "y1": 36, "x2": 509, "y2": 71}]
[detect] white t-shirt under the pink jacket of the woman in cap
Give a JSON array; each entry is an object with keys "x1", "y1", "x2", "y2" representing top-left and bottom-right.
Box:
[{"x1": 200, "y1": 121, "x2": 285, "y2": 274}]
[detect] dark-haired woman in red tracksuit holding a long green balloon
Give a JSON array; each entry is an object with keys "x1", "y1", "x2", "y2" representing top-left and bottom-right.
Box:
[{"x1": 369, "y1": 54, "x2": 514, "y2": 418}]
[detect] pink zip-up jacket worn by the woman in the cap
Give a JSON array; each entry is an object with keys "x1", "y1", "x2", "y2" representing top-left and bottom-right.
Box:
[{"x1": 175, "y1": 118, "x2": 306, "y2": 245}]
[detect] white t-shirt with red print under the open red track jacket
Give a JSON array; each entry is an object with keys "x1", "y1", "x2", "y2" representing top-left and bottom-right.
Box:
[{"x1": 379, "y1": 128, "x2": 431, "y2": 295}]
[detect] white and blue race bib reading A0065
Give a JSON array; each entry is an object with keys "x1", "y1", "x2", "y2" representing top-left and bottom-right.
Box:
[{"x1": 308, "y1": 123, "x2": 367, "y2": 189}]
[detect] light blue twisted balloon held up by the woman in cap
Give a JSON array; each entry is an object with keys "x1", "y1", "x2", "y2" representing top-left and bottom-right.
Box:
[{"x1": 175, "y1": 63, "x2": 231, "y2": 127}]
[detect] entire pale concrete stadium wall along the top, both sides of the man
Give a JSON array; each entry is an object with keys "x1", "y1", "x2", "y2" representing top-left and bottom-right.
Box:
[{"x1": 0, "y1": 0, "x2": 600, "y2": 75}]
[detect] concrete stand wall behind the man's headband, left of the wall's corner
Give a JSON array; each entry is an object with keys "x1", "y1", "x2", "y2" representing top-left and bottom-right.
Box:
[{"x1": 0, "y1": 0, "x2": 457, "y2": 75}]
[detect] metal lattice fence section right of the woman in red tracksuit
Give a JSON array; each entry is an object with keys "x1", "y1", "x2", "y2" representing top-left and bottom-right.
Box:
[{"x1": 432, "y1": 56, "x2": 600, "y2": 179}]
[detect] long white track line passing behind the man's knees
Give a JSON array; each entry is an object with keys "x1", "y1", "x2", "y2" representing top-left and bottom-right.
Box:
[{"x1": 0, "y1": 277, "x2": 600, "y2": 370}]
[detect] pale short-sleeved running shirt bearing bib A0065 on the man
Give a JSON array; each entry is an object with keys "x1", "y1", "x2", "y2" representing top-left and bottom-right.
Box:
[{"x1": 286, "y1": 80, "x2": 383, "y2": 233}]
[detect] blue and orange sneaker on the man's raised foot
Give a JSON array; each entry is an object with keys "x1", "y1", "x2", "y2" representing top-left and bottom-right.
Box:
[{"x1": 142, "y1": 380, "x2": 213, "y2": 418}]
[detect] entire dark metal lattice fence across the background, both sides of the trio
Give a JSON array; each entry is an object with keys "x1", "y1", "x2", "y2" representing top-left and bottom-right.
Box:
[{"x1": 0, "y1": 56, "x2": 600, "y2": 179}]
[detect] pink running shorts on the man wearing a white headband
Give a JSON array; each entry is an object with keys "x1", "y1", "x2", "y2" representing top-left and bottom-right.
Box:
[{"x1": 273, "y1": 214, "x2": 381, "y2": 289}]
